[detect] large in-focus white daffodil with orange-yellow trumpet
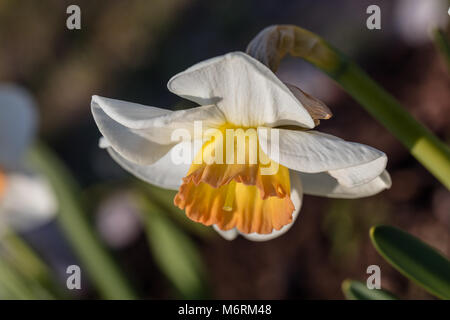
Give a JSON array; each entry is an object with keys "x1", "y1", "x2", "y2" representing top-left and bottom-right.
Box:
[{"x1": 91, "y1": 52, "x2": 390, "y2": 240}]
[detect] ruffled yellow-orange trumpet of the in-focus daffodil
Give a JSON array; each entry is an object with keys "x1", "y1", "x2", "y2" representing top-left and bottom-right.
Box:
[{"x1": 174, "y1": 125, "x2": 294, "y2": 234}]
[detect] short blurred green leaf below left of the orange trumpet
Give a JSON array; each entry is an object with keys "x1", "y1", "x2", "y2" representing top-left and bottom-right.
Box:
[{"x1": 139, "y1": 193, "x2": 207, "y2": 299}]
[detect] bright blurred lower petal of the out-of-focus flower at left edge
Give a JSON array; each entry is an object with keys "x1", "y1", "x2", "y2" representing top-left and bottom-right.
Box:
[{"x1": 0, "y1": 172, "x2": 58, "y2": 231}]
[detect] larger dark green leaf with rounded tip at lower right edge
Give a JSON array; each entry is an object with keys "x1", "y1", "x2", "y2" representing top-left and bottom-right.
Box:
[{"x1": 370, "y1": 225, "x2": 450, "y2": 299}]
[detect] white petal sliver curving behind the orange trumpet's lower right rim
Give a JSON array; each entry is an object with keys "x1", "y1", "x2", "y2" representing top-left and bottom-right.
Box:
[{"x1": 242, "y1": 171, "x2": 303, "y2": 241}]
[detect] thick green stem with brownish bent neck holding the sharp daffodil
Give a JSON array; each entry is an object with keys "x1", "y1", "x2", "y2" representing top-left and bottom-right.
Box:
[{"x1": 247, "y1": 25, "x2": 450, "y2": 189}]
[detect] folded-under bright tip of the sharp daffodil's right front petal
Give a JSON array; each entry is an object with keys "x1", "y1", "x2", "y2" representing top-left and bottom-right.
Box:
[{"x1": 328, "y1": 155, "x2": 387, "y2": 187}]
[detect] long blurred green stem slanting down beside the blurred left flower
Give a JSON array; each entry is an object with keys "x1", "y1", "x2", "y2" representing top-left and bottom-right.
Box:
[{"x1": 30, "y1": 144, "x2": 136, "y2": 299}]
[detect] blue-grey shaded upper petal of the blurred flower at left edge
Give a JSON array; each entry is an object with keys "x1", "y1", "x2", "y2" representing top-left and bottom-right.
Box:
[{"x1": 0, "y1": 85, "x2": 37, "y2": 169}]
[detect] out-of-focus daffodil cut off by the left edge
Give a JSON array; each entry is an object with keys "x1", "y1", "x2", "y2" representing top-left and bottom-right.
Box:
[{"x1": 0, "y1": 84, "x2": 57, "y2": 235}]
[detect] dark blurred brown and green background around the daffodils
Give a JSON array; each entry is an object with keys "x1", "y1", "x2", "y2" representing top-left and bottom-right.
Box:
[{"x1": 0, "y1": 0, "x2": 450, "y2": 299}]
